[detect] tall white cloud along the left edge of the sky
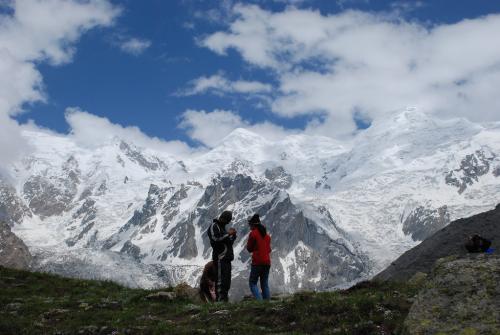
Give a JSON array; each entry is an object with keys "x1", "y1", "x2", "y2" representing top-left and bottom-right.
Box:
[{"x1": 0, "y1": 0, "x2": 120, "y2": 178}]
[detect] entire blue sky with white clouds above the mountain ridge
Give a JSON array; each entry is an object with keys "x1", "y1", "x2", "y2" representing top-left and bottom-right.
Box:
[{"x1": 0, "y1": 0, "x2": 500, "y2": 172}]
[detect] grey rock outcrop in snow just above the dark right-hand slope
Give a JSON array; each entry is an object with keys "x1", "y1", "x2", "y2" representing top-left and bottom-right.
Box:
[{"x1": 403, "y1": 206, "x2": 450, "y2": 241}]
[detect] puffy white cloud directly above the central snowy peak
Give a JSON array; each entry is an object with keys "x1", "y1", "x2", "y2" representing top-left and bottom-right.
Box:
[{"x1": 179, "y1": 110, "x2": 297, "y2": 148}]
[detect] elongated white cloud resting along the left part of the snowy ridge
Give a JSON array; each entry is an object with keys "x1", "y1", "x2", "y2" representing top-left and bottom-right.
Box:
[{"x1": 65, "y1": 107, "x2": 192, "y2": 155}]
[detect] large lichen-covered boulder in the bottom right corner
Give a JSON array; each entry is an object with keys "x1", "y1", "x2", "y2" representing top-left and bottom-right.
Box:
[{"x1": 404, "y1": 254, "x2": 500, "y2": 335}]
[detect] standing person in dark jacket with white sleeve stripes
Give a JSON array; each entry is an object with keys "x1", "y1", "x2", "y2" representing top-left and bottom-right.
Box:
[{"x1": 207, "y1": 211, "x2": 236, "y2": 301}]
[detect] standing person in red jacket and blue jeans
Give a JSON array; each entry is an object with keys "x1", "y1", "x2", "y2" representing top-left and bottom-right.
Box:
[{"x1": 247, "y1": 214, "x2": 271, "y2": 300}]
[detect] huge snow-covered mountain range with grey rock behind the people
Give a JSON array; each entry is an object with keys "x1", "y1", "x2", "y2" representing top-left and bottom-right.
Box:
[{"x1": 0, "y1": 109, "x2": 500, "y2": 295}]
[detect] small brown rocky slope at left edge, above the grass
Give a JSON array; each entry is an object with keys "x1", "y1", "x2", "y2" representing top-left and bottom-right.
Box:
[{"x1": 0, "y1": 221, "x2": 32, "y2": 269}]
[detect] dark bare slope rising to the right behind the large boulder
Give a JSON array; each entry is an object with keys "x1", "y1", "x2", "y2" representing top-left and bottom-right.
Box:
[{"x1": 375, "y1": 205, "x2": 500, "y2": 280}]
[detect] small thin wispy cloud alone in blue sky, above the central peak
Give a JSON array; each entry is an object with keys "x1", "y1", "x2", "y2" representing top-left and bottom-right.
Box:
[{"x1": 177, "y1": 74, "x2": 272, "y2": 96}]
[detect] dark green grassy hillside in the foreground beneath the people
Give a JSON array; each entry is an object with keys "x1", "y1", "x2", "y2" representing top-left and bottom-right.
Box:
[{"x1": 0, "y1": 267, "x2": 416, "y2": 335}]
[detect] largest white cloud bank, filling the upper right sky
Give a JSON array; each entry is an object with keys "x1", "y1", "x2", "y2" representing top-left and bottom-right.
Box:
[{"x1": 201, "y1": 2, "x2": 500, "y2": 136}]
